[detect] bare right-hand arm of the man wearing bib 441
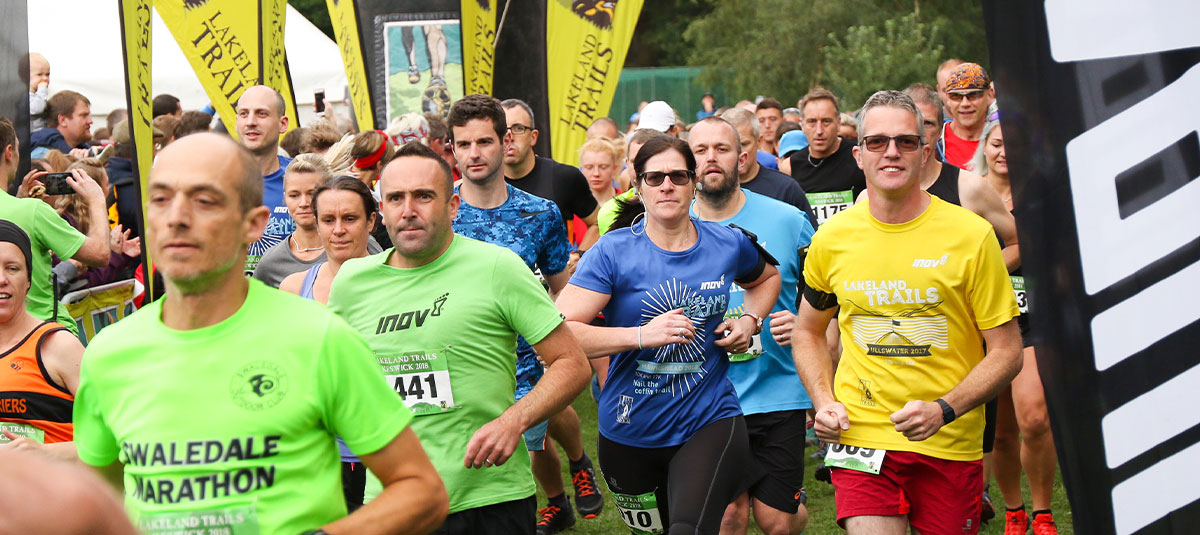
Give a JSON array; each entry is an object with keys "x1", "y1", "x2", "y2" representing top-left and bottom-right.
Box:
[{"x1": 463, "y1": 323, "x2": 592, "y2": 468}]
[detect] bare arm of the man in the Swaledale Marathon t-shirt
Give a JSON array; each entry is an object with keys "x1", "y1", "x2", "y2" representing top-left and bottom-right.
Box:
[{"x1": 323, "y1": 427, "x2": 450, "y2": 535}]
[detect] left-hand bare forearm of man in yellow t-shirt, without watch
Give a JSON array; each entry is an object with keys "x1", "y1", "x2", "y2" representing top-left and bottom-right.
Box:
[{"x1": 792, "y1": 297, "x2": 850, "y2": 443}]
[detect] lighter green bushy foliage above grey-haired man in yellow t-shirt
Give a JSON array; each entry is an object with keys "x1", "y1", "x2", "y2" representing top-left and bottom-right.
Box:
[{"x1": 822, "y1": 12, "x2": 946, "y2": 109}]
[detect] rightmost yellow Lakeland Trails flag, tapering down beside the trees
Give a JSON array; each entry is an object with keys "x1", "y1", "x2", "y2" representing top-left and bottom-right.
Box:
[{"x1": 546, "y1": 0, "x2": 642, "y2": 166}]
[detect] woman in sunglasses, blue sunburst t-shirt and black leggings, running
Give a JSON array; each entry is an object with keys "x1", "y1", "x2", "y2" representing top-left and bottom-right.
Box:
[{"x1": 558, "y1": 136, "x2": 780, "y2": 534}]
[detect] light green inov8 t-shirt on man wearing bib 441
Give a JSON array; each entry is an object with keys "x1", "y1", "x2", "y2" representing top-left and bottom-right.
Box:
[{"x1": 329, "y1": 235, "x2": 563, "y2": 512}]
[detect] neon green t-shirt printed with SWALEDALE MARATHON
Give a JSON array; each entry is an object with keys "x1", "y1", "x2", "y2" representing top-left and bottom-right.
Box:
[{"x1": 74, "y1": 279, "x2": 413, "y2": 535}]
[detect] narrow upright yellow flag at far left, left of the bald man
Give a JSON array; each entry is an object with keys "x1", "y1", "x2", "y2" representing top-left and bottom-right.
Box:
[{"x1": 120, "y1": 0, "x2": 154, "y2": 302}]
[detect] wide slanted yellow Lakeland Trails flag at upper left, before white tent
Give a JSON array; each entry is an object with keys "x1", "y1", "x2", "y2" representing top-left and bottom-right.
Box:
[{"x1": 154, "y1": 0, "x2": 296, "y2": 137}]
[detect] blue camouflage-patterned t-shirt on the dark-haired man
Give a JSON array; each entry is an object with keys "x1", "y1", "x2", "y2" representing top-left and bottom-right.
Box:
[{"x1": 454, "y1": 185, "x2": 570, "y2": 399}]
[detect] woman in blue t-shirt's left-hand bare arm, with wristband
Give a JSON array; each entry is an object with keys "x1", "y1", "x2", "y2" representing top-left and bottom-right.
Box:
[{"x1": 552, "y1": 284, "x2": 696, "y2": 359}]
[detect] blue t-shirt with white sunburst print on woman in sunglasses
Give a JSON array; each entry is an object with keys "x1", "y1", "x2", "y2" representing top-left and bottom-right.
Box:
[{"x1": 570, "y1": 218, "x2": 758, "y2": 447}]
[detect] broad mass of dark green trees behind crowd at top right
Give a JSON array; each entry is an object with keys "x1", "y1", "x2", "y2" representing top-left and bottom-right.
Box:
[{"x1": 681, "y1": 0, "x2": 988, "y2": 104}]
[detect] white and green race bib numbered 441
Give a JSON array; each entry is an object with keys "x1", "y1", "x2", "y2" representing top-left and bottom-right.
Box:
[{"x1": 376, "y1": 347, "x2": 458, "y2": 416}]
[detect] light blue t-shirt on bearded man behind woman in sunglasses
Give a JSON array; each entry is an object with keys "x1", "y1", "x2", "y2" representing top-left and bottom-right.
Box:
[{"x1": 692, "y1": 188, "x2": 815, "y2": 414}]
